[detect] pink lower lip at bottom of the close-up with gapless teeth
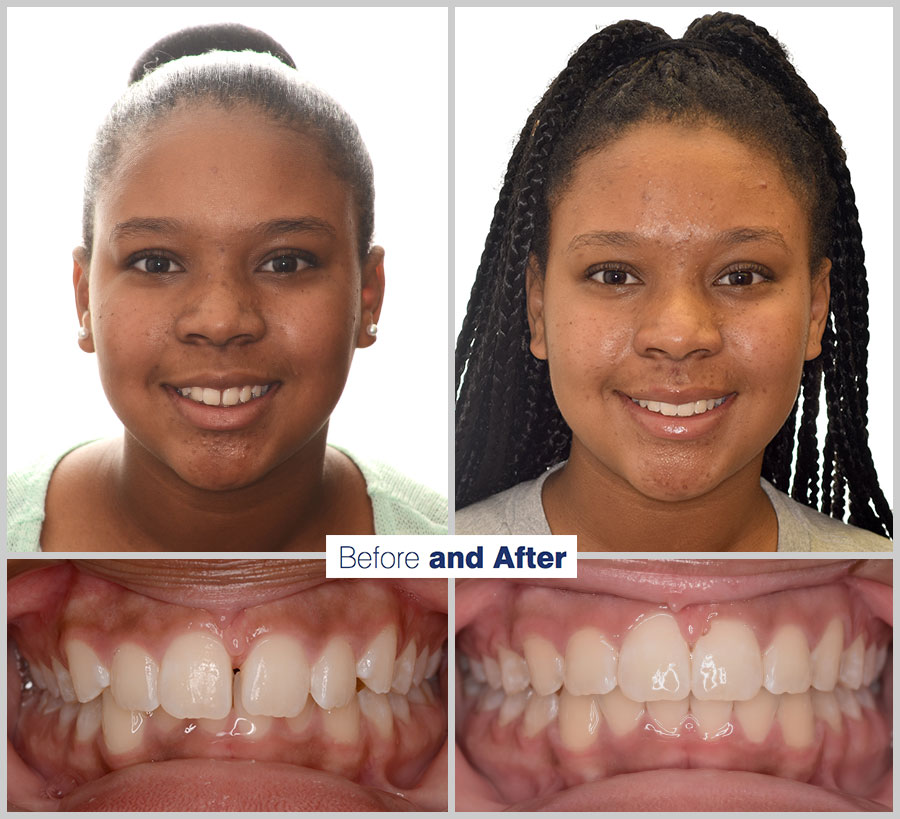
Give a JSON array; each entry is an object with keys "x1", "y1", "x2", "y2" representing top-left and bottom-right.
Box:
[{"x1": 514, "y1": 770, "x2": 889, "y2": 812}]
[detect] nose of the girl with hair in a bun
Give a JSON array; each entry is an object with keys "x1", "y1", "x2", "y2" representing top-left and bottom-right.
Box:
[{"x1": 176, "y1": 271, "x2": 266, "y2": 347}]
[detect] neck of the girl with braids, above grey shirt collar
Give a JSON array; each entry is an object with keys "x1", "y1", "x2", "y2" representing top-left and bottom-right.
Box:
[{"x1": 543, "y1": 445, "x2": 778, "y2": 552}]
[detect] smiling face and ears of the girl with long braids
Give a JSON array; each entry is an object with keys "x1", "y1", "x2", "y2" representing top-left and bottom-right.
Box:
[{"x1": 528, "y1": 124, "x2": 830, "y2": 501}]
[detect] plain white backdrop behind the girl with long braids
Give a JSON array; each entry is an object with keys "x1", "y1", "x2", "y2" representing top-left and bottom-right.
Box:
[{"x1": 454, "y1": 6, "x2": 893, "y2": 506}]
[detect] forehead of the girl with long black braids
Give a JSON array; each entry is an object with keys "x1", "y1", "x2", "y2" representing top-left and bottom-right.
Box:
[{"x1": 551, "y1": 124, "x2": 809, "y2": 250}]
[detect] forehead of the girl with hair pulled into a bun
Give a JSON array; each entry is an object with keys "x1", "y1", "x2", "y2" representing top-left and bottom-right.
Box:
[{"x1": 95, "y1": 105, "x2": 355, "y2": 239}]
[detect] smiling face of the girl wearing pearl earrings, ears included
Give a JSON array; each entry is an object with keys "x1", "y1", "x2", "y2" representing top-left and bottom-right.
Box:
[{"x1": 74, "y1": 105, "x2": 384, "y2": 489}]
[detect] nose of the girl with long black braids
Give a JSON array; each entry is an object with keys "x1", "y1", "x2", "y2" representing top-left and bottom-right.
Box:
[{"x1": 634, "y1": 284, "x2": 722, "y2": 361}]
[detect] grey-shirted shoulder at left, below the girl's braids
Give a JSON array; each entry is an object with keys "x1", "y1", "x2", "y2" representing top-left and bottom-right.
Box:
[{"x1": 455, "y1": 467, "x2": 558, "y2": 535}]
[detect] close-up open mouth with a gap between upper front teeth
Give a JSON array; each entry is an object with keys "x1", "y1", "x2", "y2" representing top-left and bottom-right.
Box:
[{"x1": 8, "y1": 564, "x2": 446, "y2": 810}]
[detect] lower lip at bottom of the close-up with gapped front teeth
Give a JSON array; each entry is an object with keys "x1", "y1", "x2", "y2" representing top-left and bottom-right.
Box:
[{"x1": 59, "y1": 759, "x2": 414, "y2": 811}]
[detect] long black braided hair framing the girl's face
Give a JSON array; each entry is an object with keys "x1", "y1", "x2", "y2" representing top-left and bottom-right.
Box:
[{"x1": 456, "y1": 12, "x2": 893, "y2": 535}]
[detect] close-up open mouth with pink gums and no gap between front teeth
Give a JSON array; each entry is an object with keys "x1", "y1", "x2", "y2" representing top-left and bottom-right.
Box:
[{"x1": 457, "y1": 561, "x2": 893, "y2": 810}]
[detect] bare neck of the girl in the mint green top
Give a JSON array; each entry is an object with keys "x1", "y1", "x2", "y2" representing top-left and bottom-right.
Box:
[{"x1": 105, "y1": 427, "x2": 331, "y2": 552}]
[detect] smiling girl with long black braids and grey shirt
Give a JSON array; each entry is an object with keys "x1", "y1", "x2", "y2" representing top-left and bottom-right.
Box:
[{"x1": 456, "y1": 13, "x2": 892, "y2": 551}]
